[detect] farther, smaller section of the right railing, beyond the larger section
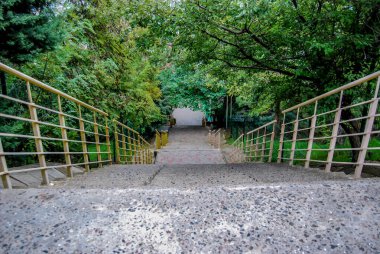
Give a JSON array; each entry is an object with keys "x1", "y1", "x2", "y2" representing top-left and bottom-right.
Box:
[{"x1": 244, "y1": 120, "x2": 277, "y2": 162}]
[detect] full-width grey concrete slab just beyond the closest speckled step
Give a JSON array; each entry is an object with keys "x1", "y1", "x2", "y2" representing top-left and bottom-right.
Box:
[{"x1": 48, "y1": 163, "x2": 348, "y2": 189}]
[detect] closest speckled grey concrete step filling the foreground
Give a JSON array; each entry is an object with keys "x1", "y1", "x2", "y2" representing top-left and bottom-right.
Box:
[{"x1": 0, "y1": 180, "x2": 380, "y2": 253}]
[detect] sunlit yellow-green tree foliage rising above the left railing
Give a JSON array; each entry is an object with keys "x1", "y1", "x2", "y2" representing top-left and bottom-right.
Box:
[{"x1": 18, "y1": 1, "x2": 161, "y2": 128}]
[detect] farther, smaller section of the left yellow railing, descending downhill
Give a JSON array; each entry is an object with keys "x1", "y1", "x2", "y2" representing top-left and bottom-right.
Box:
[{"x1": 113, "y1": 120, "x2": 153, "y2": 164}]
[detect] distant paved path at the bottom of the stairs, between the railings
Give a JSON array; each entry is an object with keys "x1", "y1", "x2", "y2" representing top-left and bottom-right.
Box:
[{"x1": 156, "y1": 126, "x2": 225, "y2": 165}]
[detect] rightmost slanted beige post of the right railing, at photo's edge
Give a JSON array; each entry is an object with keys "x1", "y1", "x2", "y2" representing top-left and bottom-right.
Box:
[{"x1": 354, "y1": 77, "x2": 380, "y2": 178}]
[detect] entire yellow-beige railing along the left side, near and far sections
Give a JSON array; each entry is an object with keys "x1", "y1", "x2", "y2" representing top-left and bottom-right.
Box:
[{"x1": 0, "y1": 63, "x2": 153, "y2": 188}]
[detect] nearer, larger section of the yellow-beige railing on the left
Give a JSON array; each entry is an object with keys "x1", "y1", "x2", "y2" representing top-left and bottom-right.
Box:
[{"x1": 0, "y1": 63, "x2": 112, "y2": 189}]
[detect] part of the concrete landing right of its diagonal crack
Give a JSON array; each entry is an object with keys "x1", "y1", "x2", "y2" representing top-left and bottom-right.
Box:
[{"x1": 149, "y1": 163, "x2": 349, "y2": 189}]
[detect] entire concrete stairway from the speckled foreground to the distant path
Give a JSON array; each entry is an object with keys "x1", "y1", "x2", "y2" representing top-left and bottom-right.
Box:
[{"x1": 0, "y1": 128, "x2": 380, "y2": 253}]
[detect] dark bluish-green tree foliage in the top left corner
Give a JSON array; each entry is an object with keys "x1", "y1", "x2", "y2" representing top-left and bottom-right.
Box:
[{"x1": 0, "y1": 0, "x2": 62, "y2": 94}]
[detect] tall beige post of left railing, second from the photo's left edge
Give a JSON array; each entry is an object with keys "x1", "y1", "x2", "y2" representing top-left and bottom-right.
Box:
[{"x1": 26, "y1": 81, "x2": 49, "y2": 185}]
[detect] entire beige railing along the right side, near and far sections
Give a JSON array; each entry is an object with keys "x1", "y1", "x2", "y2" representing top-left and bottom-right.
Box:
[{"x1": 234, "y1": 71, "x2": 380, "y2": 178}]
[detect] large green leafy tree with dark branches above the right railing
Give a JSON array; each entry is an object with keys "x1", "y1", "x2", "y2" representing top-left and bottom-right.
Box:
[{"x1": 160, "y1": 0, "x2": 380, "y2": 159}]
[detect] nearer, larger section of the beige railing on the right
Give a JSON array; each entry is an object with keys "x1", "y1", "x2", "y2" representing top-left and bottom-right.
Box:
[{"x1": 278, "y1": 71, "x2": 380, "y2": 178}]
